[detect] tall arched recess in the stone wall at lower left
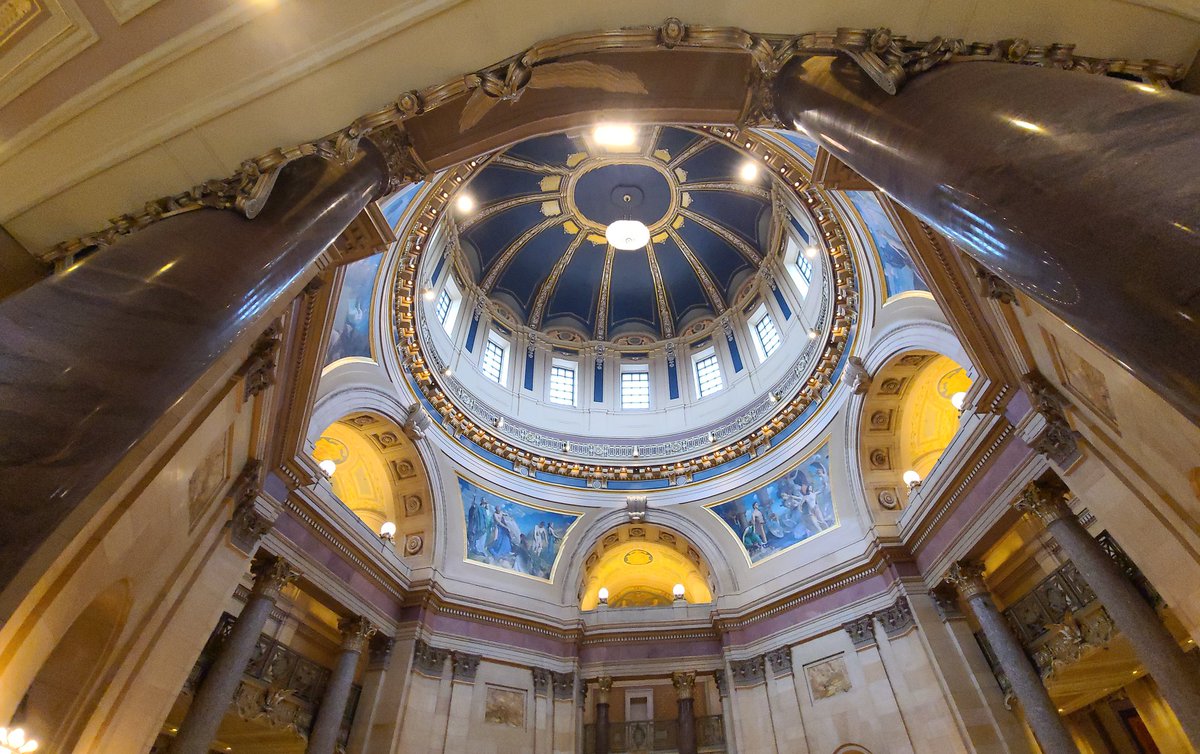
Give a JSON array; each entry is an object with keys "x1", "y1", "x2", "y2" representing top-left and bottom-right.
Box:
[{"x1": 19, "y1": 580, "x2": 133, "y2": 752}]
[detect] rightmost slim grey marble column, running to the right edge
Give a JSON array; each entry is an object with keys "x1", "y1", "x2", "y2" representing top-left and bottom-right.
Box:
[{"x1": 1014, "y1": 478, "x2": 1200, "y2": 748}]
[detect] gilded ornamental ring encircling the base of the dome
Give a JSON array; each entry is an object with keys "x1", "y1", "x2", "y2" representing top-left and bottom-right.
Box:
[{"x1": 392, "y1": 126, "x2": 858, "y2": 486}]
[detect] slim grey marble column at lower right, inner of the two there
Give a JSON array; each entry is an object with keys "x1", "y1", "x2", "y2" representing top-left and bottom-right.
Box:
[{"x1": 946, "y1": 561, "x2": 1079, "y2": 754}]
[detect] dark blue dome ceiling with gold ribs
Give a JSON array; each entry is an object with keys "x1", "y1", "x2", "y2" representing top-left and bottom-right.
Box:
[{"x1": 458, "y1": 126, "x2": 772, "y2": 342}]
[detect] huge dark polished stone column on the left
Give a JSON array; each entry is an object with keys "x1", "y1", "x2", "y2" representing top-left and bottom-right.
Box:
[{"x1": 0, "y1": 138, "x2": 388, "y2": 588}]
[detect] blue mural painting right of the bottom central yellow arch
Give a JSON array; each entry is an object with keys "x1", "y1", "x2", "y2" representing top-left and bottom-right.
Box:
[{"x1": 709, "y1": 445, "x2": 838, "y2": 564}]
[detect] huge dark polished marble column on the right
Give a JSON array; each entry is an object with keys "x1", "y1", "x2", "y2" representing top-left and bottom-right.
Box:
[{"x1": 773, "y1": 57, "x2": 1200, "y2": 421}]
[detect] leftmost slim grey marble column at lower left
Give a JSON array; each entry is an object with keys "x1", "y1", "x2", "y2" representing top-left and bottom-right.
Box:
[{"x1": 169, "y1": 557, "x2": 296, "y2": 754}]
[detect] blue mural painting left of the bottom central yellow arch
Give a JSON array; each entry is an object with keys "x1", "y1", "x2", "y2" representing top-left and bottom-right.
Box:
[{"x1": 458, "y1": 477, "x2": 580, "y2": 581}]
